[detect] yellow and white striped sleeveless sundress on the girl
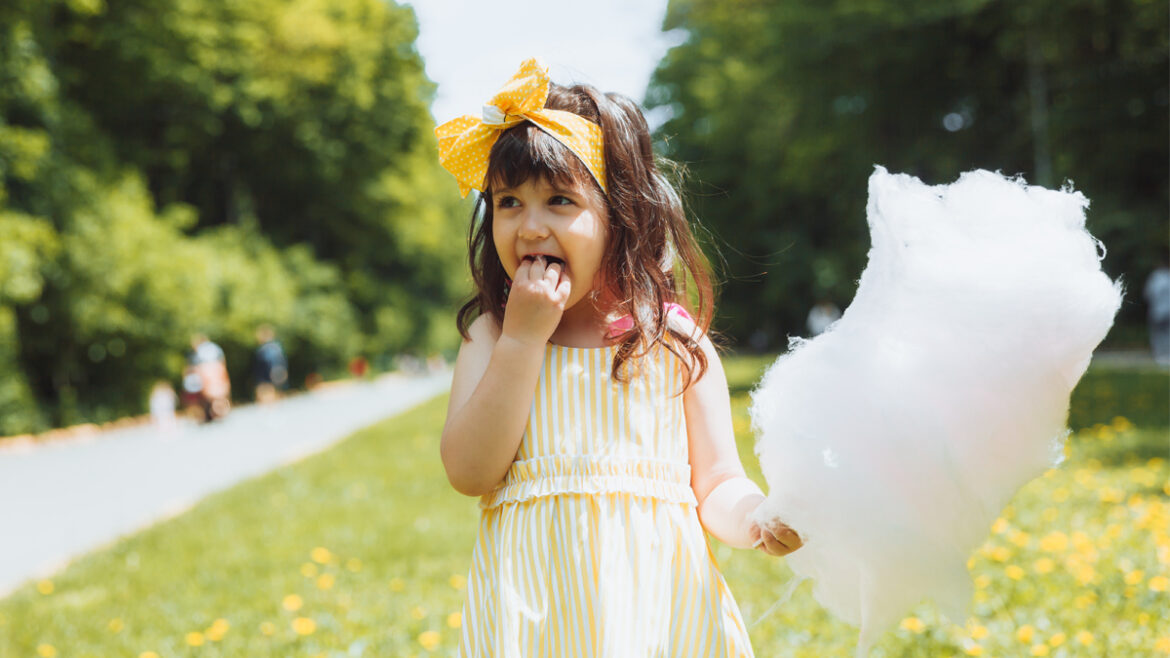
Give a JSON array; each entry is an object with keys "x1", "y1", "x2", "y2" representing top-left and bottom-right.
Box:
[{"x1": 459, "y1": 343, "x2": 752, "y2": 658}]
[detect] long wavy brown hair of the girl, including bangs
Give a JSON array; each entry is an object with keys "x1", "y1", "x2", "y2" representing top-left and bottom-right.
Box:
[{"x1": 456, "y1": 84, "x2": 714, "y2": 388}]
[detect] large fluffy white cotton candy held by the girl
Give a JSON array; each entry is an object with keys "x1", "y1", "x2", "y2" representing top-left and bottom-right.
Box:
[{"x1": 751, "y1": 166, "x2": 1121, "y2": 656}]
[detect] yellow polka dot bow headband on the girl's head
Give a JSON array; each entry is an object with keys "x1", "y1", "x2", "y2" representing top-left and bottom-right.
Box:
[{"x1": 435, "y1": 59, "x2": 605, "y2": 197}]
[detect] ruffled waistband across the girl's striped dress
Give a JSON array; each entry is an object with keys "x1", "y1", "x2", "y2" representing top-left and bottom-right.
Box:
[{"x1": 480, "y1": 454, "x2": 697, "y2": 509}]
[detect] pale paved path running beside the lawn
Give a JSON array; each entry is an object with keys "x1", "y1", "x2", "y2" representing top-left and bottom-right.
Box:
[{"x1": 0, "y1": 371, "x2": 450, "y2": 596}]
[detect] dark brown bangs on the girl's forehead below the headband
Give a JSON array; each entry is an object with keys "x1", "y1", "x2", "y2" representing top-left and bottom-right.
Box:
[{"x1": 487, "y1": 122, "x2": 605, "y2": 199}]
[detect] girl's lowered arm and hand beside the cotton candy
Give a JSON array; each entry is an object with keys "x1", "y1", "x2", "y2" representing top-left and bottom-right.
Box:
[{"x1": 683, "y1": 327, "x2": 800, "y2": 555}]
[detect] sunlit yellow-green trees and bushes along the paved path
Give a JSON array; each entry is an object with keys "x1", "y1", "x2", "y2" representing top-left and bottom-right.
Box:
[{"x1": 0, "y1": 0, "x2": 466, "y2": 436}]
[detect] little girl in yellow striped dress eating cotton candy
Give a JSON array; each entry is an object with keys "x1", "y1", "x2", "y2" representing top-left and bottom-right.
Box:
[{"x1": 435, "y1": 60, "x2": 800, "y2": 658}]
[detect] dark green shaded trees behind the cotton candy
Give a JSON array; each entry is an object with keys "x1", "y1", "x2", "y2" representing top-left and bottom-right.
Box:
[{"x1": 647, "y1": 0, "x2": 1170, "y2": 347}]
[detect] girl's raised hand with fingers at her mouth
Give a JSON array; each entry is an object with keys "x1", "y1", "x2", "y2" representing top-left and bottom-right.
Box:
[{"x1": 501, "y1": 256, "x2": 570, "y2": 345}]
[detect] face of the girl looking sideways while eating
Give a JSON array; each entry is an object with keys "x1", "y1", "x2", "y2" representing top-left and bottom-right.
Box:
[{"x1": 491, "y1": 179, "x2": 608, "y2": 309}]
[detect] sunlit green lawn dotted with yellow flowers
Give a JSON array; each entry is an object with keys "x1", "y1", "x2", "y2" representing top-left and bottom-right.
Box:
[{"x1": 0, "y1": 357, "x2": 1170, "y2": 658}]
